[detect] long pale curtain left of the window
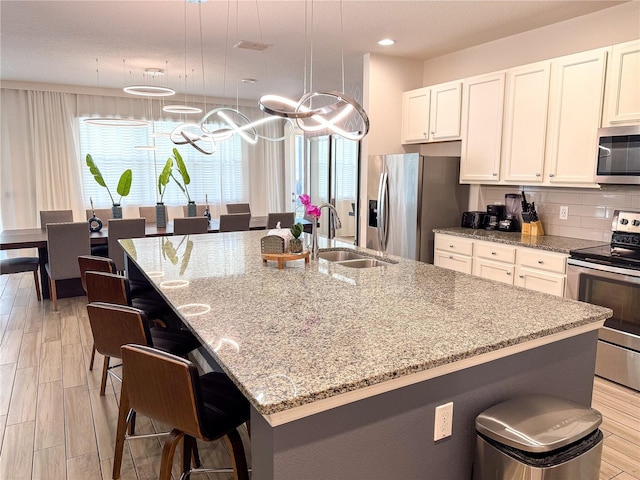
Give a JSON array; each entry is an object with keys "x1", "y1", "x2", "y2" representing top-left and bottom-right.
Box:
[{"x1": 0, "y1": 89, "x2": 84, "y2": 229}]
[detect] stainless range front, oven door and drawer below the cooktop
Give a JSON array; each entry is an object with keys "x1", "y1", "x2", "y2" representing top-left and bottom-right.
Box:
[{"x1": 565, "y1": 258, "x2": 640, "y2": 390}]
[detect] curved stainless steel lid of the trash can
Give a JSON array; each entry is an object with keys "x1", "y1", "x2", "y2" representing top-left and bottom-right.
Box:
[{"x1": 476, "y1": 395, "x2": 602, "y2": 453}]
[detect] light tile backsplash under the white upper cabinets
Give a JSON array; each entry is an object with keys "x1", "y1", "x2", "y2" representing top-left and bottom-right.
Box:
[{"x1": 479, "y1": 185, "x2": 640, "y2": 242}]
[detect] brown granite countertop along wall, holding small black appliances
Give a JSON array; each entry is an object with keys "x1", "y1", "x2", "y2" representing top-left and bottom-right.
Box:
[{"x1": 433, "y1": 227, "x2": 607, "y2": 254}]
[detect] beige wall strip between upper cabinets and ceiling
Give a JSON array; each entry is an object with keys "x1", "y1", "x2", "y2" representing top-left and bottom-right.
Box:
[{"x1": 423, "y1": 1, "x2": 640, "y2": 86}]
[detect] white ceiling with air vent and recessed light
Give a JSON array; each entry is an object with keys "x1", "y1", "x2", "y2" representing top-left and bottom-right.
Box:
[{"x1": 0, "y1": 0, "x2": 623, "y2": 99}]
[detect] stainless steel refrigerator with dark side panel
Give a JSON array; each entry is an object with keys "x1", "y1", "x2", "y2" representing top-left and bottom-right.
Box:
[{"x1": 367, "y1": 153, "x2": 469, "y2": 263}]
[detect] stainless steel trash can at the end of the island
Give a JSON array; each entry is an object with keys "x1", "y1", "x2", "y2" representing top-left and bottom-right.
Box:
[{"x1": 473, "y1": 395, "x2": 602, "y2": 480}]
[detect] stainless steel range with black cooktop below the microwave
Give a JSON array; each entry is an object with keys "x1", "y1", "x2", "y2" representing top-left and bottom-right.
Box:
[{"x1": 566, "y1": 210, "x2": 640, "y2": 390}]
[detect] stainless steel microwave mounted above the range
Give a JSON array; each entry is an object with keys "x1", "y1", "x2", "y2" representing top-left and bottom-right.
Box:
[{"x1": 595, "y1": 125, "x2": 640, "y2": 185}]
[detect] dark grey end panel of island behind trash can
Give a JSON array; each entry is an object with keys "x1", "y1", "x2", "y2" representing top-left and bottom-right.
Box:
[{"x1": 251, "y1": 331, "x2": 597, "y2": 480}]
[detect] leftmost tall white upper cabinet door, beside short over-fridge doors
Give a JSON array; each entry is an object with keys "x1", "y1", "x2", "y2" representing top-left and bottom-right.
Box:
[{"x1": 460, "y1": 72, "x2": 504, "y2": 183}]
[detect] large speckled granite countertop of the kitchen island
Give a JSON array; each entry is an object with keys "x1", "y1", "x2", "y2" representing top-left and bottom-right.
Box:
[{"x1": 122, "y1": 231, "x2": 611, "y2": 424}]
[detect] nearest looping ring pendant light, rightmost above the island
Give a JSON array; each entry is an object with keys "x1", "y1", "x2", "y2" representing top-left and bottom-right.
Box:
[{"x1": 258, "y1": 0, "x2": 369, "y2": 140}]
